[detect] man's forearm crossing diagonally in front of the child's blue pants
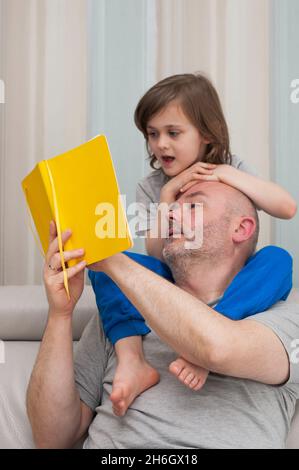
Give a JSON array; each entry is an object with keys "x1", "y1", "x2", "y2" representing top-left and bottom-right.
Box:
[{"x1": 103, "y1": 254, "x2": 230, "y2": 370}]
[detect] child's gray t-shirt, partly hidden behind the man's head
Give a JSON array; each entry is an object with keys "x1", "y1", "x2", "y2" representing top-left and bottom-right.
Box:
[{"x1": 136, "y1": 155, "x2": 256, "y2": 236}]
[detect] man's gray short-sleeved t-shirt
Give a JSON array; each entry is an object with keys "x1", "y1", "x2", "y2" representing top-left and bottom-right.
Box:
[{"x1": 75, "y1": 302, "x2": 299, "y2": 449}]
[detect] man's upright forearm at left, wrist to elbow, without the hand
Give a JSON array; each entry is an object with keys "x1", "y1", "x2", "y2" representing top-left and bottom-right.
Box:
[{"x1": 27, "y1": 314, "x2": 81, "y2": 448}]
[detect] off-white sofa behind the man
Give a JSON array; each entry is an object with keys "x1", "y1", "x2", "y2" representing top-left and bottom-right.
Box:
[{"x1": 0, "y1": 286, "x2": 299, "y2": 449}]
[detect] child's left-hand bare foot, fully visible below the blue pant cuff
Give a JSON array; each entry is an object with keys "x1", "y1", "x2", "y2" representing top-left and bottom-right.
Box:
[{"x1": 110, "y1": 357, "x2": 160, "y2": 416}]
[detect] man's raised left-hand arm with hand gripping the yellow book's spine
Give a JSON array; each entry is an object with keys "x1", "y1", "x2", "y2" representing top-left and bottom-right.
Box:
[{"x1": 27, "y1": 221, "x2": 93, "y2": 448}]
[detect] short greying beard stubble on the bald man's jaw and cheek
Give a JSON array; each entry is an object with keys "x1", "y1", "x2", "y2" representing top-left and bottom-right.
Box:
[{"x1": 163, "y1": 217, "x2": 231, "y2": 284}]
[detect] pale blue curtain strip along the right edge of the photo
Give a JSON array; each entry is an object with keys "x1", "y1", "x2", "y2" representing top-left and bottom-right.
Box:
[{"x1": 270, "y1": 0, "x2": 299, "y2": 287}]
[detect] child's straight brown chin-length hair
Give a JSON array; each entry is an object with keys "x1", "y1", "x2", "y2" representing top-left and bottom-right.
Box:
[{"x1": 134, "y1": 73, "x2": 231, "y2": 169}]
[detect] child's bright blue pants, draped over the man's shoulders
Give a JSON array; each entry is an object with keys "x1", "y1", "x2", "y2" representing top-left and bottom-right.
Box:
[{"x1": 88, "y1": 246, "x2": 293, "y2": 344}]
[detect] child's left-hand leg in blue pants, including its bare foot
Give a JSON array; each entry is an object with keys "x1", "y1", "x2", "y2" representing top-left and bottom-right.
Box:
[{"x1": 89, "y1": 252, "x2": 173, "y2": 416}]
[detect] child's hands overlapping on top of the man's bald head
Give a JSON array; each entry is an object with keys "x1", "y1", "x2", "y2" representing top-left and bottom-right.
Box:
[{"x1": 160, "y1": 162, "x2": 219, "y2": 204}]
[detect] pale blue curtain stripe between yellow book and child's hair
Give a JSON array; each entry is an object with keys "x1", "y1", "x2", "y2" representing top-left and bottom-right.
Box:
[{"x1": 88, "y1": 0, "x2": 157, "y2": 258}]
